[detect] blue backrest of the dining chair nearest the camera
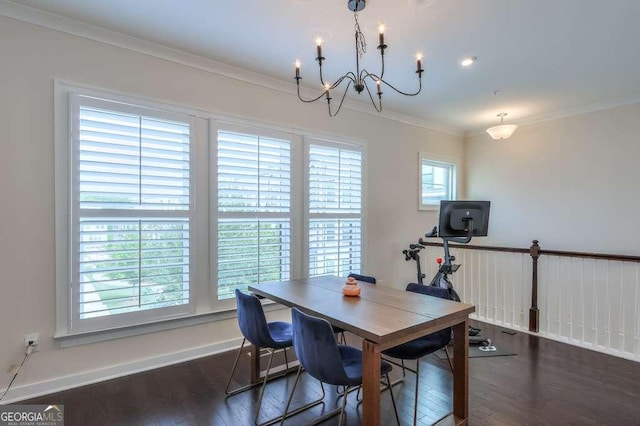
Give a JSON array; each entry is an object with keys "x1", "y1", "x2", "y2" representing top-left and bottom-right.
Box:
[{"x1": 291, "y1": 308, "x2": 349, "y2": 385}]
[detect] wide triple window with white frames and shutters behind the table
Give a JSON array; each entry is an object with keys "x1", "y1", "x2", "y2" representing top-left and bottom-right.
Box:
[{"x1": 55, "y1": 82, "x2": 364, "y2": 347}]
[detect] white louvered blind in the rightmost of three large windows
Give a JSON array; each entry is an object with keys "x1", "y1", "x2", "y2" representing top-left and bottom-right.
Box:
[{"x1": 308, "y1": 144, "x2": 362, "y2": 276}]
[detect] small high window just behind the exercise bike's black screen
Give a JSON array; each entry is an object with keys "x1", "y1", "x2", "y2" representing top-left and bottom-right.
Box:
[{"x1": 419, "y1": 153, "x2": 456, "y2": 210}]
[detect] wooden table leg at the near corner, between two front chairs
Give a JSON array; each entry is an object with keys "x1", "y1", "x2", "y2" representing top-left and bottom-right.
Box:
[{"x1": 362, "y1": 339, "x2": 381, "y2": 426}]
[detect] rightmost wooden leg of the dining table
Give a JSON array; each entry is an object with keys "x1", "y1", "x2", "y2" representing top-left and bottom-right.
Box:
[{"x1": 453, "y1": 319, "x2": 469, "y2": 425}]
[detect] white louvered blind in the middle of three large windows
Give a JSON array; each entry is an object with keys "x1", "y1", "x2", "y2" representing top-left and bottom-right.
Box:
[{"x1": 217, "y1": 130, "x2": 291, "y2": 300}]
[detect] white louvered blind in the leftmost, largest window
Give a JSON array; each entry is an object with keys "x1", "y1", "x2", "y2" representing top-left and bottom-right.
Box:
[{"x1": 71, "y1": 96, "x2": 191, "y2": 320}]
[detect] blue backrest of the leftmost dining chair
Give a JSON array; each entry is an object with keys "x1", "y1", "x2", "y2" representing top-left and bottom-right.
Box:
[{"x1": 236, "y1": 289, "x2": 274, "y2": 348}]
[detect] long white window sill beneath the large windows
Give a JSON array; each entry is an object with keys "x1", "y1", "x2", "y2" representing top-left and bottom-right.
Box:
[{"x1": 53, "y1": 301, "x2": 285, "y2": 348}]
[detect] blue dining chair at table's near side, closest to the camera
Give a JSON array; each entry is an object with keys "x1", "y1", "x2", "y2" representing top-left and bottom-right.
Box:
[{"x1": 283, "y1": 308, "x2": 400, "y2": 425}]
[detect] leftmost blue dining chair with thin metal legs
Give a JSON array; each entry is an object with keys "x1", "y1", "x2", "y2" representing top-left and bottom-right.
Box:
[{"x1": 225, "y1": 289, "x2": 293, "y2": 422}]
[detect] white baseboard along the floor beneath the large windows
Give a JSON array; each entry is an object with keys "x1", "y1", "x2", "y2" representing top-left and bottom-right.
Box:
[{"x1": 0, "y1": 338, "x2": 242, "y2": 404}]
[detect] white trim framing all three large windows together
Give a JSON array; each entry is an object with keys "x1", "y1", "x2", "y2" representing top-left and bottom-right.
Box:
[{"x1": 53, "y1": 79, "x2": 367, "y2": 347}]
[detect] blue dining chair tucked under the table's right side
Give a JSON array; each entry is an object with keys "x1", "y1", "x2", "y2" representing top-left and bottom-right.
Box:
[{"x1": 382, "y1": 283, "x2": 453, "y2": 426}]
